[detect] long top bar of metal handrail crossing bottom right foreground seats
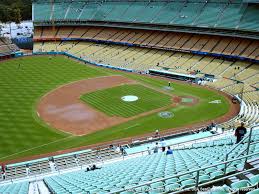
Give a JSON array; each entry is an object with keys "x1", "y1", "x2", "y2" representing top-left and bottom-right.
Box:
[{"x1": 108, "y1": 152, "x2": 259, "y2": 194}]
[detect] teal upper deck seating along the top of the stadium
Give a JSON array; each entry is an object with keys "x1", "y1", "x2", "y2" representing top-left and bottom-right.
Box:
[{"x1": 33, "y1": 0, "x2": 259, "y2": 32}]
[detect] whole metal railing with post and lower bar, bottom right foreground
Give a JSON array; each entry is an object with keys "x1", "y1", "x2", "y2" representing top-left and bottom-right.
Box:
[{"x1": 109, "y1": 152, "x2": 259, "y2": 194}]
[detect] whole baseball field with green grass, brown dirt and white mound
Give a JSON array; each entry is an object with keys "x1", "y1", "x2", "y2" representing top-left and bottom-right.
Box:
[{"x1": 0, "y1": 56, "x2": 236, "y2": 162}]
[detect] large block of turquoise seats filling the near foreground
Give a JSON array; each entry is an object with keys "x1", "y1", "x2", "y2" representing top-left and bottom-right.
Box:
[{"x1": 3, "y1": 129, "x2": 259, "y2": 194}]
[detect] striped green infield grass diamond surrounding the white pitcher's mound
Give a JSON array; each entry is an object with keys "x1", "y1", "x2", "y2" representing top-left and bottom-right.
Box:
[{"x1": 81, "y1": 84, "x2": 172, "y2": 118}]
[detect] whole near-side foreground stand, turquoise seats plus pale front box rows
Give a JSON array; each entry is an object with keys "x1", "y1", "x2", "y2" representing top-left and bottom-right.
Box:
[{"x1": 0, "y1": 125, "x2": 259, "y2": 193}]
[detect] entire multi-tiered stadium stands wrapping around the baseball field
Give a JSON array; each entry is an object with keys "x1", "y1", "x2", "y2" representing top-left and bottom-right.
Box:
[{"x1": 0, "y1": 0, "x2": 259, "y2": 194}]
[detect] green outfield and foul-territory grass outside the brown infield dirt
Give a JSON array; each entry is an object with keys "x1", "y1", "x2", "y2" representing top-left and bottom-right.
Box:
[{"x1": 0, "y1": 56, "x2": 232, "y2": 161}]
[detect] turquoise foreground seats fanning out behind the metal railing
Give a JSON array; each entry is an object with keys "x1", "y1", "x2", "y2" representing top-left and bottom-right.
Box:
[{"x1": 37, "y1": 131, "x2": 259, "y2": 193}]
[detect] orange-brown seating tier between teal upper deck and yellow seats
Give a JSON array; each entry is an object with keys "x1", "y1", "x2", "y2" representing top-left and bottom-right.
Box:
[{"x1": 34, "y1": 27, "x2": 259, "y2": 59}]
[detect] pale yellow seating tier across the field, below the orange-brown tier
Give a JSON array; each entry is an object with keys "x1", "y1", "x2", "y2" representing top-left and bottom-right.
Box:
[{"x1": 34, "y1": 41, "x2": 259, "y2": 93}]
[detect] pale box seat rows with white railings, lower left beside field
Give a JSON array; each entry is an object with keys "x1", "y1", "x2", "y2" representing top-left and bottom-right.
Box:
[{"x1": 0, "y1": 148, "x2": 120, "y2": 181}]
